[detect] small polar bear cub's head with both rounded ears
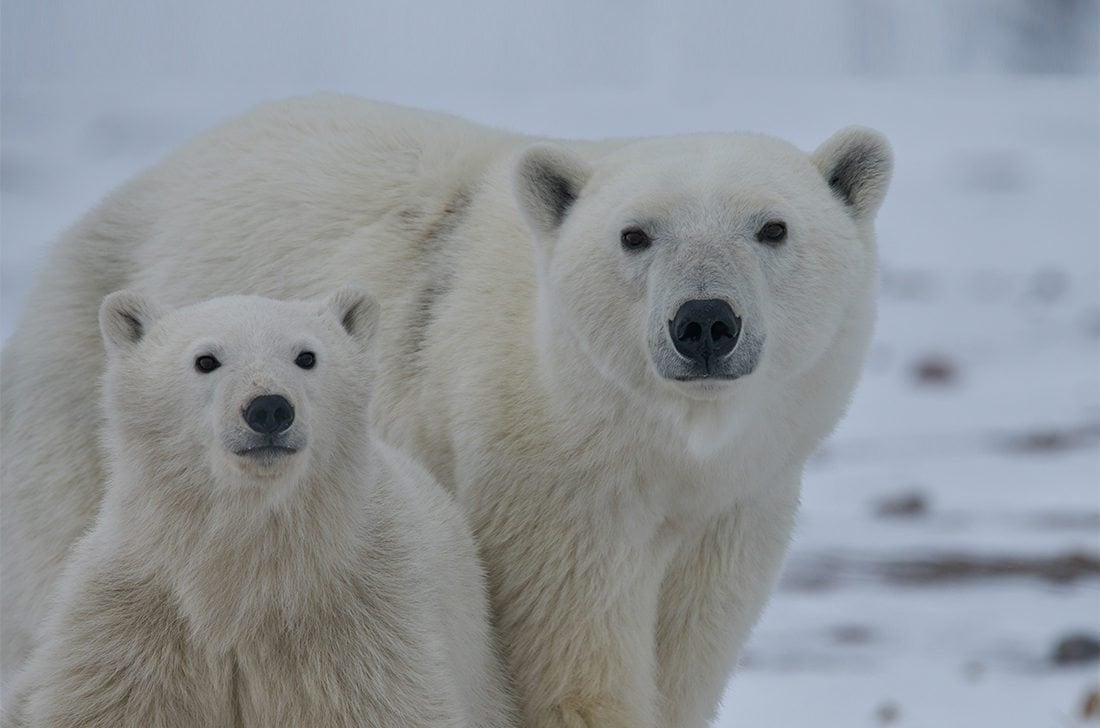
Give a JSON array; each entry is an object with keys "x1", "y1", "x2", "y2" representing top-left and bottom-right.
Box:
[{"x1": 99, "y1": 288, "x2": 377, "y2": 493}]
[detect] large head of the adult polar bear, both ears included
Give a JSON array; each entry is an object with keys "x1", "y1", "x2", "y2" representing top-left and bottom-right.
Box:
[{"x1": 515, "y1": 128, "x2": 892, "y2": 422}]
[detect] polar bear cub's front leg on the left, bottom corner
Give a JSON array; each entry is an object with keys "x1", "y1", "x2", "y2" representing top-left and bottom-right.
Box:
[{"x1": 4, "y1": 564, "x2": 233, "y2": 728}]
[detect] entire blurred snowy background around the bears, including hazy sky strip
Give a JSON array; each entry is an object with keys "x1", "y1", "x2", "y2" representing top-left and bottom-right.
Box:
[{"x1": 0, "y1": 0, "x2": 1100, "y2": 728}]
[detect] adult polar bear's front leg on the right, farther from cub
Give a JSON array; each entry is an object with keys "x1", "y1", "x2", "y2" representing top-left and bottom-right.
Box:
[{"x1": 657, "y1": 479, "x2": 799, "y2": 728}]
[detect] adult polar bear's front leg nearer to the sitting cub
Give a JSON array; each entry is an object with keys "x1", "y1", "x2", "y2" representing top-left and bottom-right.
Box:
[{"x1": 482, "y1": 512, "x2": 660, "y2": 728}]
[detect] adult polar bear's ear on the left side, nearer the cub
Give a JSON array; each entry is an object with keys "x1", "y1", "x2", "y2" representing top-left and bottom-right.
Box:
[{"x1": 514, "y1": 144, "x2": 592, "y2": 240}]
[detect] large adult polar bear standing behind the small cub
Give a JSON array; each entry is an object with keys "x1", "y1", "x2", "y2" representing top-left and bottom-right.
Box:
[{"x1": 2, "y1": 98, "x2": 891, "y2": 728}]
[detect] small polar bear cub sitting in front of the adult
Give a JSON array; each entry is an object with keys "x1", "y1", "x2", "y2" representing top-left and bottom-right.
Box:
[{"x1": 10, "y1": 288, "x2": 510, "y2": 728}]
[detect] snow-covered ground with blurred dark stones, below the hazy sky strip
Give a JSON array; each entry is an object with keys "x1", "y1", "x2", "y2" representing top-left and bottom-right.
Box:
[{"x1": 0, "y1": 3, "x2": 1100, "y2": 728}]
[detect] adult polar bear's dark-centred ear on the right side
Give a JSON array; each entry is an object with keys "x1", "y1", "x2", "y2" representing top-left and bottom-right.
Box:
[{"x1": 810, "y1": 126, "x2": 893, "y2": 220}]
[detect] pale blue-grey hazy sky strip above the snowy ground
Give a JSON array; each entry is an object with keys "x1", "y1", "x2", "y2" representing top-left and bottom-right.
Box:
[{"x1": 0, "y1": 0, "x2": 1100, "y2": 103}]
